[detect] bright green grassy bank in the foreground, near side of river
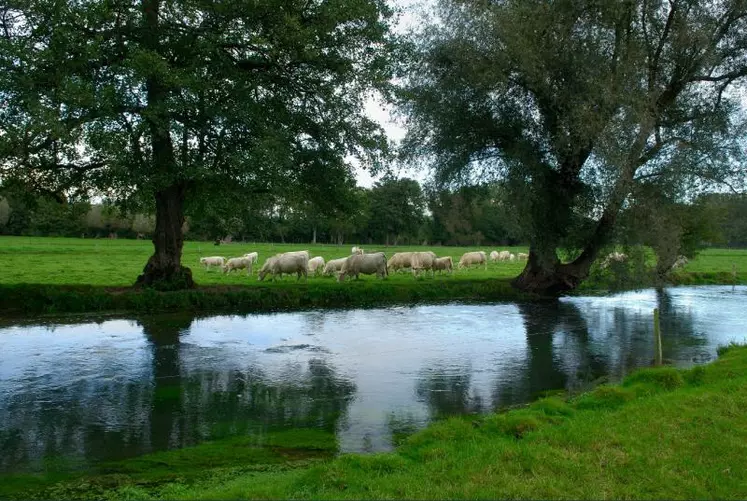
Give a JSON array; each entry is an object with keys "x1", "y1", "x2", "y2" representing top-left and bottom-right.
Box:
[{"x1": 5, "y1": 346, "x2": 747, "y2": 499}]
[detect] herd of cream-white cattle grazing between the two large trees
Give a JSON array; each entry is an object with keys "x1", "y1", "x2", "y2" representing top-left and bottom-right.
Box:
[{"x1": 200, "y1": 246, "x2": 528, "y2": 282}]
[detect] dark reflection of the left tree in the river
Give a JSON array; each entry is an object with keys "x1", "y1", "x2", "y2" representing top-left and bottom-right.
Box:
[{"x1": 0, "y1": 315, "x2": 356, "y2": 472}]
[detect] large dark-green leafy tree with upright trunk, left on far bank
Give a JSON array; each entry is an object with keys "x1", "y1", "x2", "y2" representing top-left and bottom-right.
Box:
[{"x1": 0, "y1": 0, "x2": 393, "y2": 288}]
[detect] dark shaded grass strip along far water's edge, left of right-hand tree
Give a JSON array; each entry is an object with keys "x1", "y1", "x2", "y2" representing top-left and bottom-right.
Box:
[{"x1": 0, "y1": 279, "x2": 538, "y2": 317}]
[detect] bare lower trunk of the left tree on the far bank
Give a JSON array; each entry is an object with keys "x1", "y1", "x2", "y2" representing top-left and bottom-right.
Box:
[{"x1": 136, "y1": 183, "x2": 195, "y2": 290}]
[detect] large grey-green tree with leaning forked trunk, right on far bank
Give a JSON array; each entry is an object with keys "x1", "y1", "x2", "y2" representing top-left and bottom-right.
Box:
[{"x1": 402, "y1": 0, "x2": 747, "y2": 294}]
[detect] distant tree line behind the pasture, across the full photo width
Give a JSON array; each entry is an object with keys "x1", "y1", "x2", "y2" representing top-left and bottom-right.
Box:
[{"x1": 0, "y1": 176, "x2": 747, "y2": 250}]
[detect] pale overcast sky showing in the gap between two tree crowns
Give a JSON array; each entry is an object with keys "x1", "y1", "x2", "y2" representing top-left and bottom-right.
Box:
[{"x1": 353, "y1": 0, "x2": 433, "y2": 187}]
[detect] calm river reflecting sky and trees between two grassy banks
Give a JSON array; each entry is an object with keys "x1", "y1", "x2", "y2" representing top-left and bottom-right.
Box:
[{"x1": 0, "y1": 287, "x2": 747, "y2": 472}]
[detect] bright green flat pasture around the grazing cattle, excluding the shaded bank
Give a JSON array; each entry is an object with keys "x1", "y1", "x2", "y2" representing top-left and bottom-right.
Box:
[{"x1": 0, "y1": 237, "x2": 747, "y2": 287}]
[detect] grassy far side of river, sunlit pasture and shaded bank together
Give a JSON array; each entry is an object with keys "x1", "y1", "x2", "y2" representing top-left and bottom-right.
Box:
[{"x1": 0, "y1": 237, "x2": 747, "y2": 315}]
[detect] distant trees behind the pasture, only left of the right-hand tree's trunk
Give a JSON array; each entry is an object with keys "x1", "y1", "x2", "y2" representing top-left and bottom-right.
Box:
[{"x1": 0, "y1": 176, "x2": 520, "y2": 245}]
